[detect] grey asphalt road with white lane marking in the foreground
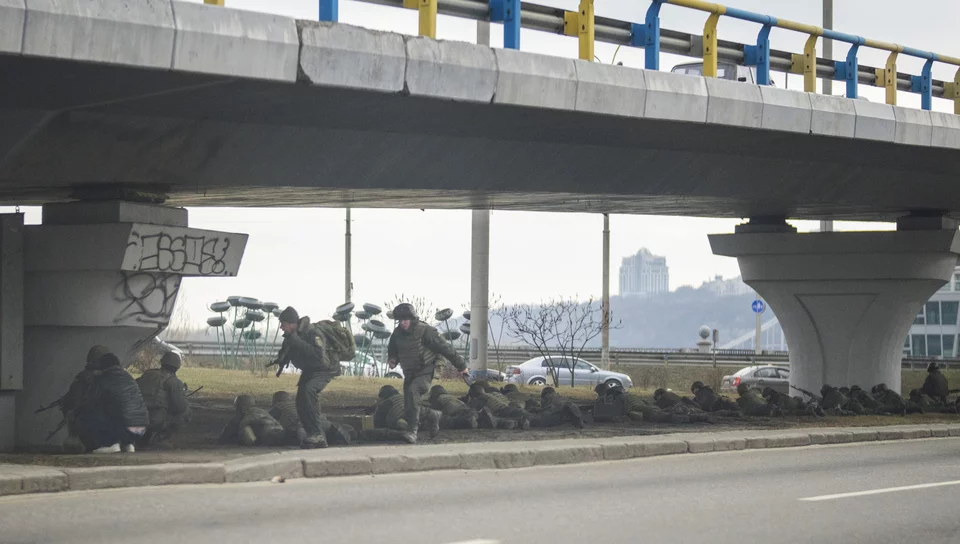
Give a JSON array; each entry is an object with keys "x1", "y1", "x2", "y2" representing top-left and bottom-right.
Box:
[{"x1": 0, "y1": 439, "x2": 960, "y2": 544}]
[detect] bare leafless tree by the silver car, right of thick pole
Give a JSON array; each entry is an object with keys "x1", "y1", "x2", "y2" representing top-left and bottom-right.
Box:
[{"x1": 507, "y1": 296, "x2": 621, "y2": 386}]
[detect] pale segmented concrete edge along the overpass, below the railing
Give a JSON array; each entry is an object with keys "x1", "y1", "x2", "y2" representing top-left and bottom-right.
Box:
[{"x1": 7, "y1": 0, "x2": 960, "y2": 149}]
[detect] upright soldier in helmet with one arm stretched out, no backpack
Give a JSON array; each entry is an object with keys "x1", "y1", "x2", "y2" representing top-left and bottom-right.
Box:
[{"x1": 387, "y1": 302, "x2": 470, "y2": 437}]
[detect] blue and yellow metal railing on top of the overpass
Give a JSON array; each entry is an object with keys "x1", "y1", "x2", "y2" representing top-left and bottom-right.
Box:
[{"x1": 204, "y1": 0, "x2": 960, "y2": 114}]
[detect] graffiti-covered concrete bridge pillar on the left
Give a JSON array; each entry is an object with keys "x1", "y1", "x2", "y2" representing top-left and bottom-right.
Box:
[{"x1": 0, "y1": 201, "x2": 247, "y2": 449}]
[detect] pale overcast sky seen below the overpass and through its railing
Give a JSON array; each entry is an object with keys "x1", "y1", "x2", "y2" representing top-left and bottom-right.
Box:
[{"x1": 15, "y1": 0, "x2": 960, "y2": 328}]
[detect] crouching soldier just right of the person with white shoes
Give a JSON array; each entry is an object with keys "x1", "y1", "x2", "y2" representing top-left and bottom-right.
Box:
[{"x1": 137, "y1": 351, "x2": 190, "y2": 448}]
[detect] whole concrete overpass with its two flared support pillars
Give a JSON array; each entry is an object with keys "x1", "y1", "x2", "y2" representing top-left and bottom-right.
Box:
[{"x1": 0, "y1": 0, "x2": 960, "y2": 447}]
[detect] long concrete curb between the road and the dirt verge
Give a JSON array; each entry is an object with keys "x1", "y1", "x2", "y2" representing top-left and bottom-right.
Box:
[{"x1": 0, "y1": 424, "x2": 960, "y2": 496}]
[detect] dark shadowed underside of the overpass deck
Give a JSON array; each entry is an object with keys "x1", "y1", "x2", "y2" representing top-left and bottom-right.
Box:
[{"x1": 0, "y1": 56, "x2": 960, "y2": 220}]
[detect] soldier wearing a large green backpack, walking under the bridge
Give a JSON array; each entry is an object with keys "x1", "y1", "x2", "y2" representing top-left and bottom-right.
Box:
[{"x1": 277, "y1": 306, "x2": 340, "y2": 449}]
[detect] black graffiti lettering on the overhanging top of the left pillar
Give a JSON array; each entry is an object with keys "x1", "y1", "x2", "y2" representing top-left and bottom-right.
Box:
[{"x1": 124, "y1": 229, "x2": 233, "y2": 276}]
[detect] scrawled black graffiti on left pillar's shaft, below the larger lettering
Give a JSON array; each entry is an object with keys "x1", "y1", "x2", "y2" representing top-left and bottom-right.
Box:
[{"x1": 114, "y1": 272, "x2": 181, "y2": 326}]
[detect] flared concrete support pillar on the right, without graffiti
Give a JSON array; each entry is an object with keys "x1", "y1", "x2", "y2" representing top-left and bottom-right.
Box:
[{"x1": 710, "y1": 217, "x2": 960, "y2": 391}]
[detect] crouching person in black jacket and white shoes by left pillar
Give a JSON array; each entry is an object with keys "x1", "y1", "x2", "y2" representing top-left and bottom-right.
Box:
[{"x1": 76, "y1": 353, "x2": 150, "y2": 453}]
